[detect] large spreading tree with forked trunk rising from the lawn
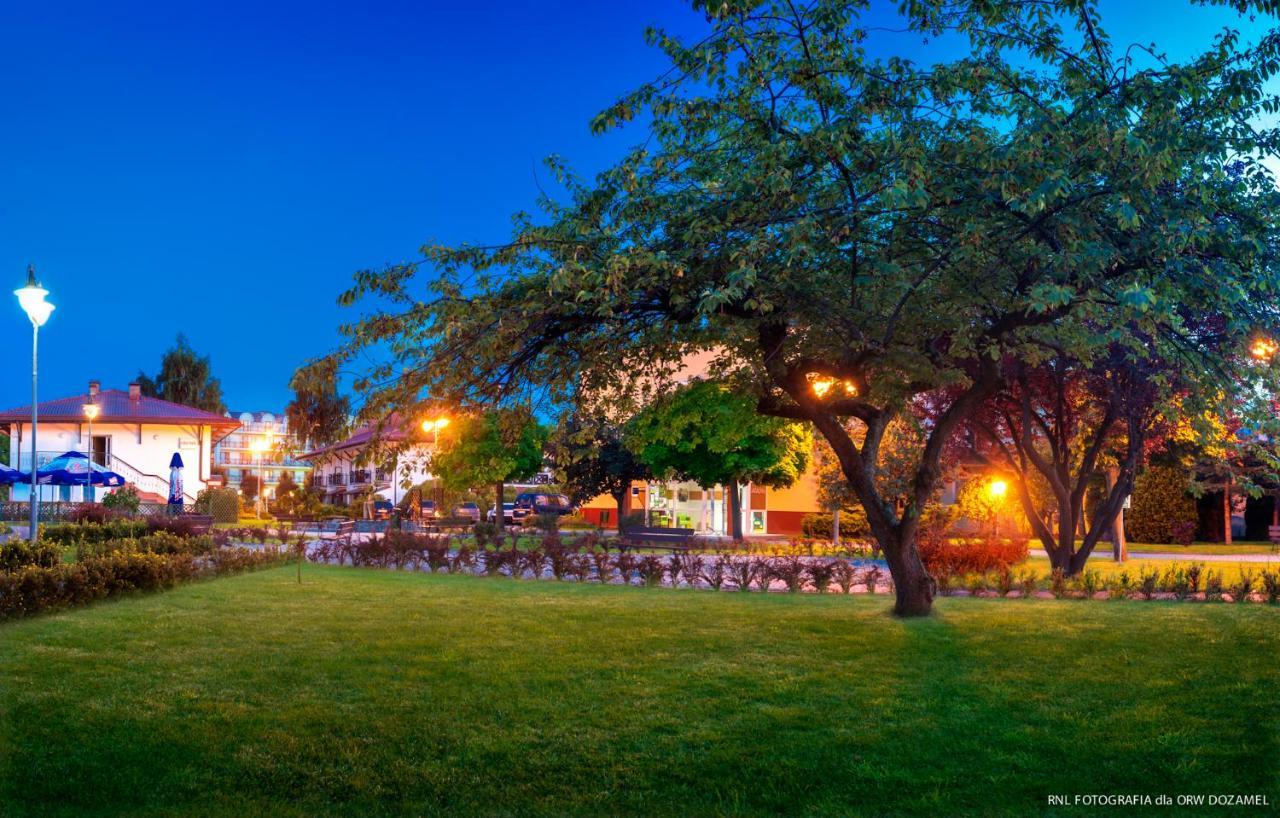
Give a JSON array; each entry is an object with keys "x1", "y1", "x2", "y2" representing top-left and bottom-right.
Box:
[{"x1": 322, "y1": 0, "x2": 1280, "y2": 614}]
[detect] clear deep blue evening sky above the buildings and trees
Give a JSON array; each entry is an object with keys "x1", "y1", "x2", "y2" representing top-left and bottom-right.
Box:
[{"x1": 0, "y1": 0, "x2": 1262, "y2": 411}]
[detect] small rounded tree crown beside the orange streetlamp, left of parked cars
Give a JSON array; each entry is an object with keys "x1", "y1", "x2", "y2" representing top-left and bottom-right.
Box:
[{"x1": 433, "y1": 411, "x2": 547, "y2": 489}]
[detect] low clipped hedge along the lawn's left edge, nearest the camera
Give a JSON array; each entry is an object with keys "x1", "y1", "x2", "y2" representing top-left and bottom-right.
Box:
[{"x1": 0, "y1": 548, "x2": 285, "y2": 620}]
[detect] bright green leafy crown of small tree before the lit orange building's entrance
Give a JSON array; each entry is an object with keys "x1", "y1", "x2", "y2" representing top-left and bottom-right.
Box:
[{"x1": 626, "y1": 380, "x2": 813, "y2": 488}]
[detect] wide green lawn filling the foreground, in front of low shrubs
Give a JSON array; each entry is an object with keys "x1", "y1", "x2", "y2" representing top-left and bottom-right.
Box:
[{"x1": 0, "y1": 566, "x2": 1280, "y2": 817}]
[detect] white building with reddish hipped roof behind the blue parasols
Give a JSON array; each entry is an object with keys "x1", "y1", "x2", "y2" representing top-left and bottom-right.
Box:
[{"x1": 0, "y1": 380, "x2": 239, "y2": 503}]
